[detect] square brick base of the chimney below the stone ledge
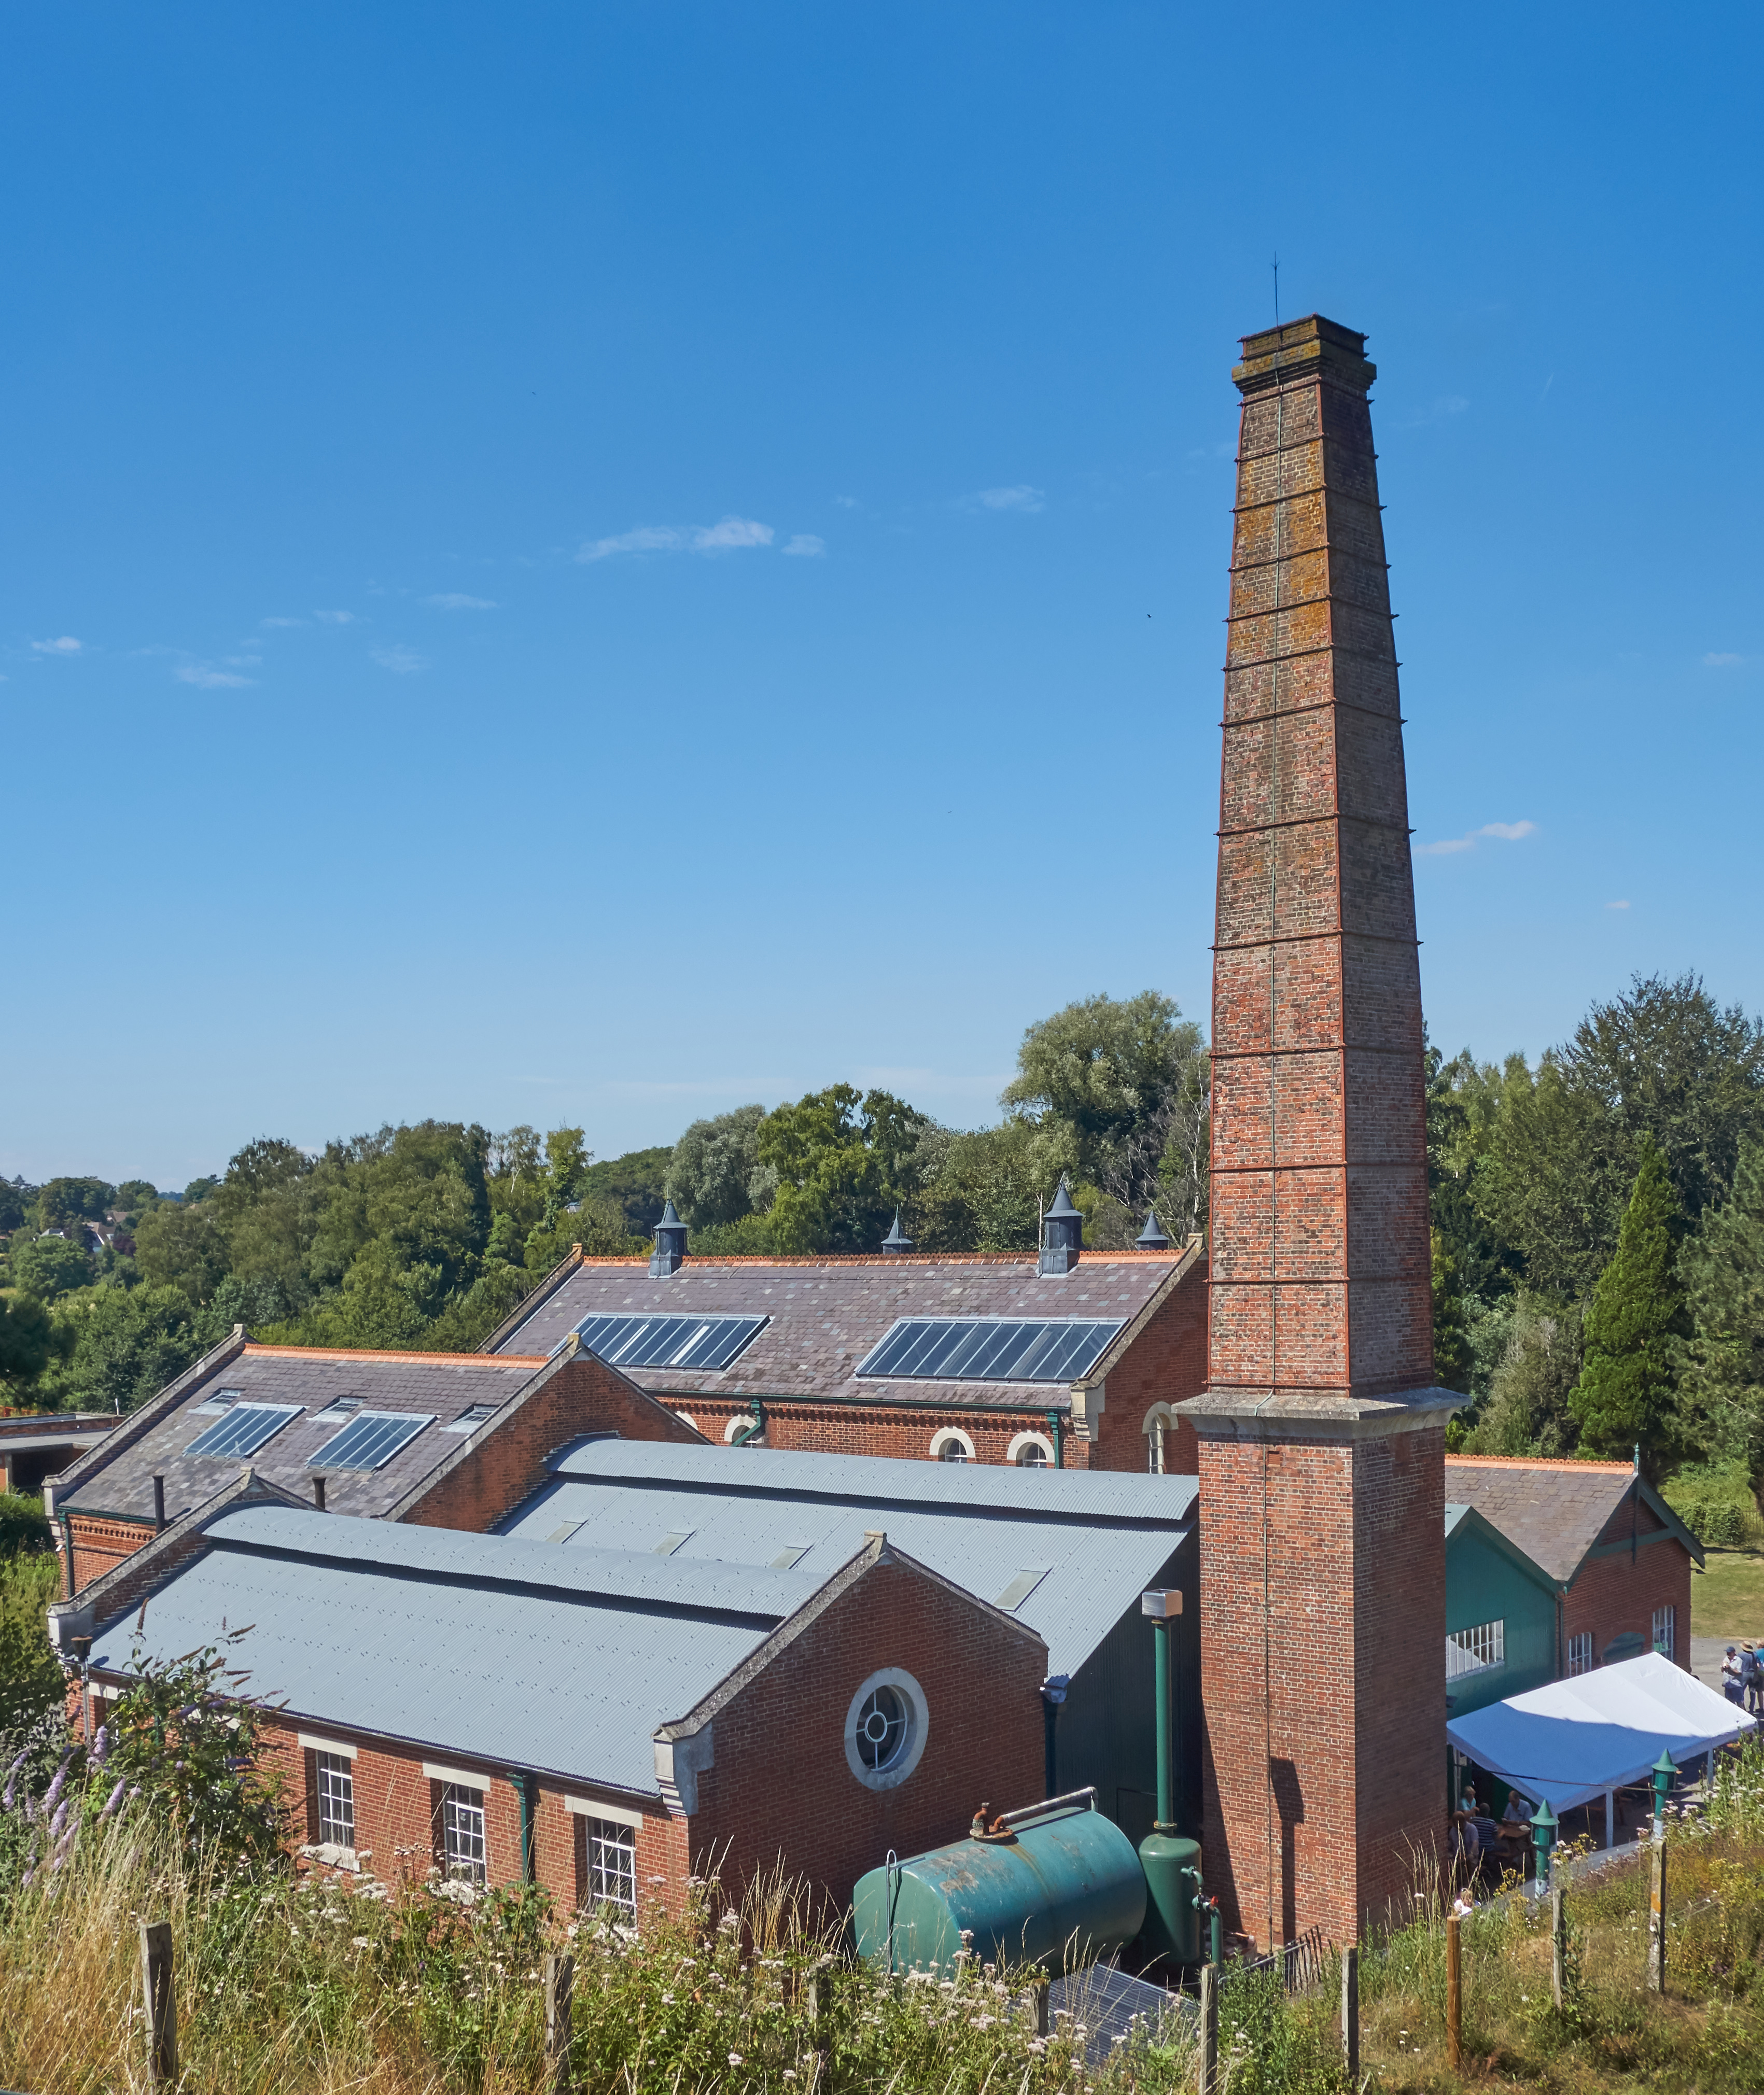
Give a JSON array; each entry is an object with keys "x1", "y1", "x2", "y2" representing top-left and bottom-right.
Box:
[{"x1": 1200, "y1": 1427, "x2": 1446, "y2": 1948}]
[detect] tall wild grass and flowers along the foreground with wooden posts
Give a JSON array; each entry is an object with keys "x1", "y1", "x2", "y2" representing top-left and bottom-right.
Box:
[{"x1": 0, "y1": 1749, "x2": 1764, "y2": 2095}]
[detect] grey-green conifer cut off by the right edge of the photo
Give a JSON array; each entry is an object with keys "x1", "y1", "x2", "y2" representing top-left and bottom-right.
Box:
[{"x1": 1678, "y1": 1142, "x2": 1764, "y2": 1502}]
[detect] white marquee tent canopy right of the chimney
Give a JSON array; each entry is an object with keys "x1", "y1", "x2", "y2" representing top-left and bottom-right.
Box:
[{"x1": 1446, "y1": 1651, "x2": 1758, "y2": 1839}]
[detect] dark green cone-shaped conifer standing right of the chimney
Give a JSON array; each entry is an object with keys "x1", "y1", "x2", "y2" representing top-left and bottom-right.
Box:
[{"x1": 1571, "y1": 1137, "x2": 1689, "y2": 1473}]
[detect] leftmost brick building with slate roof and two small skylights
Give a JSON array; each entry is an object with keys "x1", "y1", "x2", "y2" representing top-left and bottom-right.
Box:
[{"x1": 44, "y1": 1326, "x2": 697, "y2": 1594}]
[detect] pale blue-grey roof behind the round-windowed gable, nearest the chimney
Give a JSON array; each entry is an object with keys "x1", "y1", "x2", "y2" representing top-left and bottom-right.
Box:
[{"x1": 503, "y1": 1439, "x2": 1198, "y2": 1674}]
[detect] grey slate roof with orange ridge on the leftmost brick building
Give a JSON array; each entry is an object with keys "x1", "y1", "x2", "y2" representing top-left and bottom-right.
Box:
[{"x1": 54, "y1": 1343, "x2": 542, "y2": 1521}]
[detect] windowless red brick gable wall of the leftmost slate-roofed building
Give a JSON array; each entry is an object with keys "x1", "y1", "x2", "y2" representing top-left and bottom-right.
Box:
[{"x1": 396, "y1": 1353, "x2": 697, "y2": 1534}]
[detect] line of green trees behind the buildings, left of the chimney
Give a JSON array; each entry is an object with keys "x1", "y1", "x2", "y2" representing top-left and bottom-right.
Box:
[{"x1": 0, "y1": 991, "x2": 1207, "y2": 1412}]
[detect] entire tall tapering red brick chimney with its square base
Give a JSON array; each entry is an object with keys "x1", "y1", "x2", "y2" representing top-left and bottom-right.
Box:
[{"x1": 1180, "y1": 314, "x2": 1462, "y2": 1950}]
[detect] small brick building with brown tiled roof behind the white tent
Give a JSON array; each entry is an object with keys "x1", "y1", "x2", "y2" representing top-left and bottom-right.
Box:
[{"x1": 1446, "y1": 1454, "x2": 1703, "y2": 1680}]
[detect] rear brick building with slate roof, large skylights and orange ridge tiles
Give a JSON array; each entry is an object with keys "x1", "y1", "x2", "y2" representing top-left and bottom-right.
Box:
[{"x1": 473, "y1": 1230, "x2": 1207, "y2": 1475}]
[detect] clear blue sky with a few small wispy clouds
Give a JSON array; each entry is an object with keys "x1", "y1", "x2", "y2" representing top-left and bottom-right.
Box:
[{"x1": 0, "y1": 0, "x2": 1764, "y2": 1186}]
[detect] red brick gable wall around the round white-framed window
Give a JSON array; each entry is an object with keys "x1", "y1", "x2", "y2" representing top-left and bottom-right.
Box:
[{"x1": 691, "y1": 1563, "x2": 1047, "y2": 1908}]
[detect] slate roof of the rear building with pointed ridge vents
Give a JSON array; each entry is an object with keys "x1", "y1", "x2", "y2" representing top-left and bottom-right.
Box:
[{"x1": 486, "y1": 1246, "x2": 1198, "y2": 1410}]
